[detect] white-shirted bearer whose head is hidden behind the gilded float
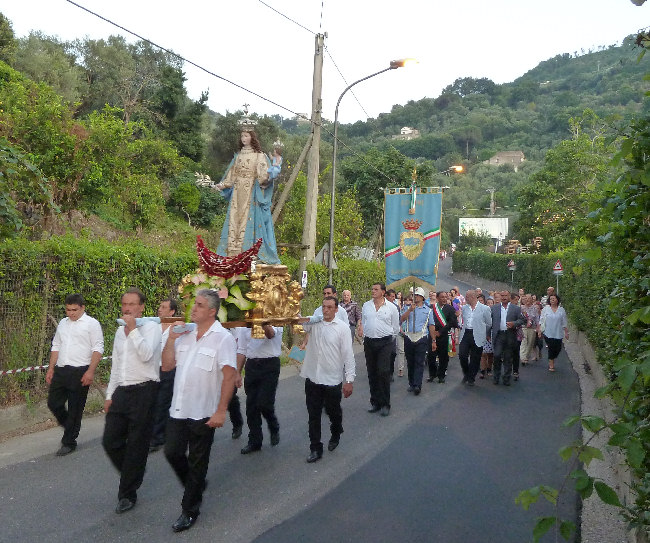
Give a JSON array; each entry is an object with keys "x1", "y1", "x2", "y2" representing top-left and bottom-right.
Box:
[{"x1": 236, "y1": 324, "x2": 283, "y2": 454}]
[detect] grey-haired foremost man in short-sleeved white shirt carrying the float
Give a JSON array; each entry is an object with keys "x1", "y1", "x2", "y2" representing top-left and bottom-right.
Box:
[{"x1": 162, "y1": 289, "x2": 237, "y2": 532}]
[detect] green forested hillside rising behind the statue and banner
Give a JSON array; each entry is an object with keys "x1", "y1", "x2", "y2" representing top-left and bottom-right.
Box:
[{"x1": 0, "y1": 7, "x2": 650, "y2": 251}]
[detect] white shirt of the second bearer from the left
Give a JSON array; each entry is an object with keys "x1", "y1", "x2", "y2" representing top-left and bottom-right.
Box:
[{"x1": 106, "y1": 321, "x2": 162, "y2": 400}]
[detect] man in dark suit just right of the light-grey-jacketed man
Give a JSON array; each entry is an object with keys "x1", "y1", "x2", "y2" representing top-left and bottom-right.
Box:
[{"x1": 491, "y1": 290, "x2": 525, "y2": 386}]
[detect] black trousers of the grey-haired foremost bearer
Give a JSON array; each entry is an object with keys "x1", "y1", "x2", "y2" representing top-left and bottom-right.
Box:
[{"x1": 165, "y1": 417, "x2": 214, "y2": 516}]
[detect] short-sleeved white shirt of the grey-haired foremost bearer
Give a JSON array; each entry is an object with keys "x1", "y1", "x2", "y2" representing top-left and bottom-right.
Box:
[{"x1": 169, "y1": 321, "x2": 237, "y2": 420}]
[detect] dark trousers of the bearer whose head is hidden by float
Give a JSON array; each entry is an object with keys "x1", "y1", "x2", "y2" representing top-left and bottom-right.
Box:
[{"x1": 244, "y1": 357, "x2": 280, "y2": 447}]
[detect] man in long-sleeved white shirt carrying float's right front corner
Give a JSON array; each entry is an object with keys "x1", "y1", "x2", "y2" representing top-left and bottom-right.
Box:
[{"x1": 300, "y1": 296, "x2": 355, "y2": 463}]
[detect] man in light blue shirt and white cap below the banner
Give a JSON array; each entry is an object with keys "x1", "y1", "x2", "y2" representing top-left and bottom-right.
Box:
[{"x1": 400, "y1": 287, "x2": 431, "y2": 396}]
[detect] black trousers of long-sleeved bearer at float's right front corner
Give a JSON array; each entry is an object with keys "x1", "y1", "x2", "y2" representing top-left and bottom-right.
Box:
[{"x1": 305, "y1": 379, "x2": 343, "y2": 453}]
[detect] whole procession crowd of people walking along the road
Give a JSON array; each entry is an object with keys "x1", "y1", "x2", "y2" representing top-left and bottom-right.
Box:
[{"x1": 46, "y1": 282, "x2": 568, "y2": 532}]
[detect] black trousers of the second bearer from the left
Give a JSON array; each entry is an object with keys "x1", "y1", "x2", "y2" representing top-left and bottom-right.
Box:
[{"x1": 102, "y1": 381, "x2": 158, "y2": 501}]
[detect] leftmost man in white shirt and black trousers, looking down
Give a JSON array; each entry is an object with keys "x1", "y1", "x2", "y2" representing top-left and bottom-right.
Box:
[{"x1": 45, "y1": 294, "x2": 104, "y2": 456}]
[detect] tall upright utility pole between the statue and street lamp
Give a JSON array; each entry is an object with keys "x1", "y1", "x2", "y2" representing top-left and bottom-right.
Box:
[{"x1": 299, "y1": 34, "x2": 327, "y2": 275}]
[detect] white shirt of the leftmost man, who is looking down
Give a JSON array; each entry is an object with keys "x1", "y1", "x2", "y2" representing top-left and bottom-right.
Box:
[{"x1": 52, "y1": 313, "x2": 104, "y2": 367}]
